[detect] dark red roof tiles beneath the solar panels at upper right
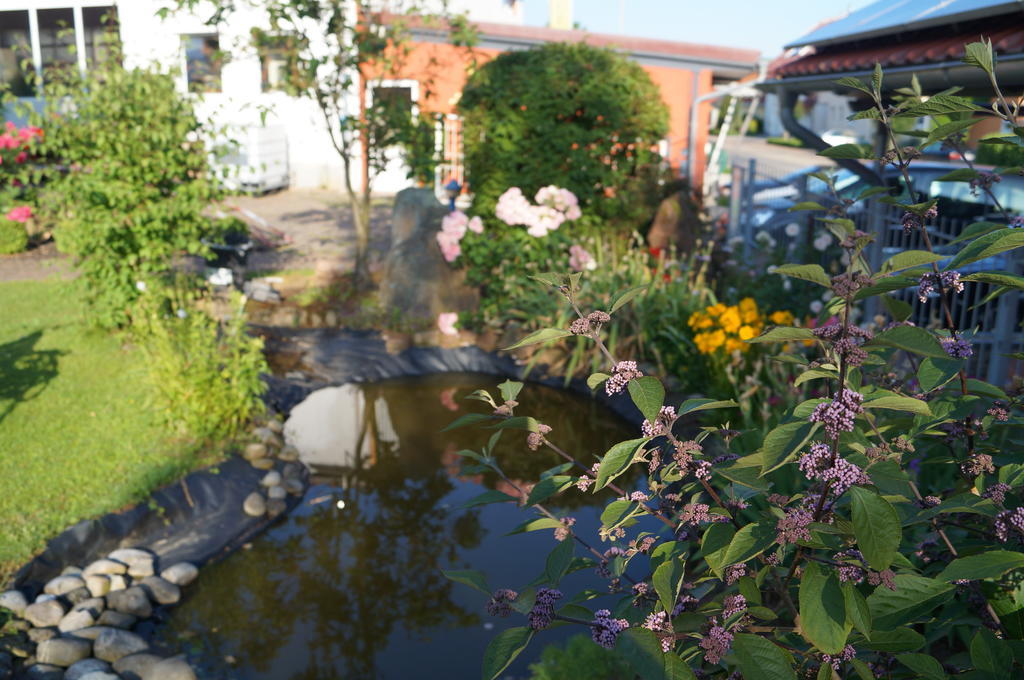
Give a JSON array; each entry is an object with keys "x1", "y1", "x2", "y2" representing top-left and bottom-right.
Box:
[{"x1": 769, "y1": 25, "x2": 1024, "y2": 79}]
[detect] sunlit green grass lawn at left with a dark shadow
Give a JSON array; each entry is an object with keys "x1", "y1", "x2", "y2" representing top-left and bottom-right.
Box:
[{"x1": 0, "y1": 282, "x2": 195, "y2": 585}]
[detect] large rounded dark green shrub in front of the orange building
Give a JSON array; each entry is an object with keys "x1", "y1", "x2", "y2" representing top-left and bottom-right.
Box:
[{"x1": 459, "y1": 43, "x2": 668, "y2": 233}]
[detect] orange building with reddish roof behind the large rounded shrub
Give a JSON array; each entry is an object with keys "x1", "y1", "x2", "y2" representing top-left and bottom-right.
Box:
[{"x1": 380, "y1": 17, "x2": 760, "y2": 192}]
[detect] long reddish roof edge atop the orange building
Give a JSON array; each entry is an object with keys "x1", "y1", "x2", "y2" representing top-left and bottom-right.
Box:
[{"x1": 384, "y1": 13, "x2": 761, "y2": 68}]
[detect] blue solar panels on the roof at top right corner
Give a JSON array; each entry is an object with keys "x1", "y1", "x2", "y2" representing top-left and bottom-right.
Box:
[{"x1": 786, "y1": 0, "x2": 1024, "y2": 48}]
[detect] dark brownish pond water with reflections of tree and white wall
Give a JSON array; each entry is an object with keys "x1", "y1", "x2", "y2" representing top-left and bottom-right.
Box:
[{"x1": 149, "y1": 375, "x2": 636, "y2": 680}]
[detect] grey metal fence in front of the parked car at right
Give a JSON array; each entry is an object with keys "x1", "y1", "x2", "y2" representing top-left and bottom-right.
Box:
[{"x1": 729, "y1": 159, "x2": 1024, "y2": 385}]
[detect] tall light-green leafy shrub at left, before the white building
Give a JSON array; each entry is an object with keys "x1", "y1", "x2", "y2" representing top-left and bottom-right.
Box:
[{"x1": 22, "y1": 59, "x2": 220, "y2": 327}]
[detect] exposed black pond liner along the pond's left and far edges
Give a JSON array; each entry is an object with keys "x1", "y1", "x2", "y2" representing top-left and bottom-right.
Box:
[{"x1": 14, "y1": 329, "x2": 642, "y2": 597}]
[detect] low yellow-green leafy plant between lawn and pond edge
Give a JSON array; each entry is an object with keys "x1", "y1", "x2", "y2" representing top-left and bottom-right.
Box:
[{"x1": 132, "y1": 279, "x2": 269, "y2": 442}]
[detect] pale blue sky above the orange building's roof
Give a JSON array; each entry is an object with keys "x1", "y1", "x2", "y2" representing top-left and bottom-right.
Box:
[{"x1": 523, "y1": 0, "x2": 872, "y2": 58}]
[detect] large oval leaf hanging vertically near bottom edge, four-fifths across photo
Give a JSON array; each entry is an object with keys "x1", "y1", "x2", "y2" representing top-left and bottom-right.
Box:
[{"x1": 800, "y1": 562, "x2": 853, "y2": 654}]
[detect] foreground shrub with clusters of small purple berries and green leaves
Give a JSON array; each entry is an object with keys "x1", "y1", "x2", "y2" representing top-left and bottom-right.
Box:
[{"x1": 447, "y1": 43, "x2": 1024, "y2": 680}]
